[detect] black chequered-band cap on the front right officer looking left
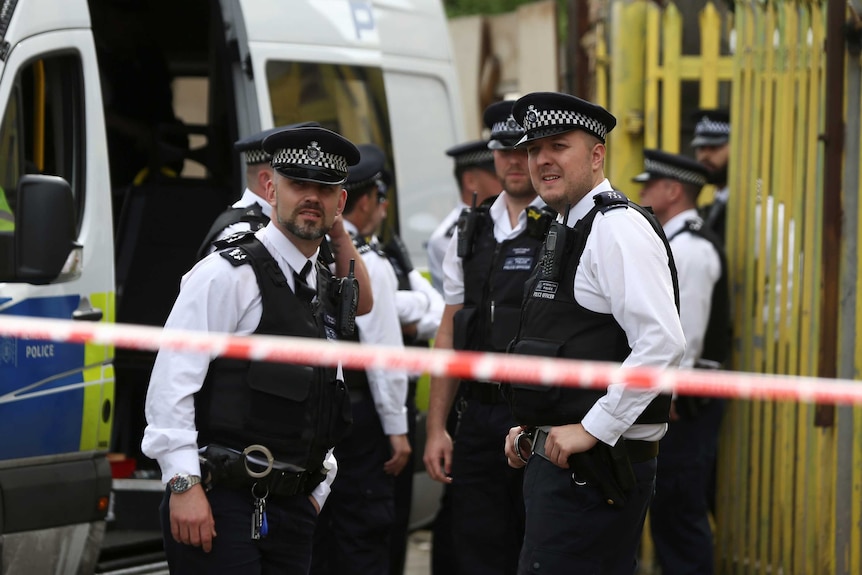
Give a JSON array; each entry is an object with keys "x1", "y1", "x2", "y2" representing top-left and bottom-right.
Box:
[{"x1": 512, "y1": 92, "x2": 617, "y2": 146}]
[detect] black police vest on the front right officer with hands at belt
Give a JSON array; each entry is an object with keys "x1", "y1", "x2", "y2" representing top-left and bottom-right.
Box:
[{"x1": 507, "y1": 192, "x2": 679, "y2": 426}]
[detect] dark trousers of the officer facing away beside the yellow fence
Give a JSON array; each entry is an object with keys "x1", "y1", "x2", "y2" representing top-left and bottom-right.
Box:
[{"x1": 650, "y1": 399, "x2": 724, "y2": 575}]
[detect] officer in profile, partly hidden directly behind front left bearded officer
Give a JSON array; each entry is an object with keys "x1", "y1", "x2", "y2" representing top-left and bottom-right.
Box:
[{"x1": 311, "y1": 145, "x2": 411, "y2": 575}]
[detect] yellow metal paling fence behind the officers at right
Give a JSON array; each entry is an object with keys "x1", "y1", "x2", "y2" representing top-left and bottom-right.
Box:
[{"x1": 595, "y1": 0, "x2": 862, "y2": 574}]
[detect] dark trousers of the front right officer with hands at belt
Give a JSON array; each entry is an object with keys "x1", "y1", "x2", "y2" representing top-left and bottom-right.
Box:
[{"x1": 518, "y1": 455, "x2": 656, "y2": 575}]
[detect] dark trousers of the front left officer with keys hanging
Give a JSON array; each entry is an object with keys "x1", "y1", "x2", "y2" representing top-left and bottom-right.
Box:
[{"x1": 160, "y1": 487, "x2": 317, "y2": 575}]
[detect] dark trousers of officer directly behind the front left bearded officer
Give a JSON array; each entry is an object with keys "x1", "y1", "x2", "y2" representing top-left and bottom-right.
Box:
[{"x1": 311, "y1": 394, "x2": 394, "y2": 575}]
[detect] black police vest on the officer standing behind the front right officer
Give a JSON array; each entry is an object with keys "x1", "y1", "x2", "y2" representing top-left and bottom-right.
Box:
[{"x1": 453, "y1": 202, "x2": 556, "y2": 353}]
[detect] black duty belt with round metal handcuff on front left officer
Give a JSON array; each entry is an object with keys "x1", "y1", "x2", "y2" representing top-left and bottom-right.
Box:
[{"x1": 198, "y1": 444, "x2": 326, "y2": 496}]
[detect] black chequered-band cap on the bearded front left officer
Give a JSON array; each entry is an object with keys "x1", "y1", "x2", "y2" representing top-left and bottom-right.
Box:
[{"x1": 263, "y1": 126, "x2": 359, "y2": 185}]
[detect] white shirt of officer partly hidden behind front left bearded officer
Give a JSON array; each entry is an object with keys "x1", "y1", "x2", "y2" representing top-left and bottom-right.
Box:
[{"x1": 344, "y1": 219, "x2": 407, "y2": 435}]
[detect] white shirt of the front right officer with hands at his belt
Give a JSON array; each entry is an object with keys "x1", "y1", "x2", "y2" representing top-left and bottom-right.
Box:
[{"x1": 561, "y1": 179, "x2": 685, "y2": 445}]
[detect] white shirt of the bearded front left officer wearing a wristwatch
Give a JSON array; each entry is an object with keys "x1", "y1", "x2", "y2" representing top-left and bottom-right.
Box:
[{"x1": 141, "y1": 224, "x2": 340, "y2": 507}]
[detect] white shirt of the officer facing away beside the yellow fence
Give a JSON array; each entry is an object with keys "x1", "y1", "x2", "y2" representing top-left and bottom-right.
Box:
[{"x1": 664, "y1": 208, "x2": 721, "y2": 368}]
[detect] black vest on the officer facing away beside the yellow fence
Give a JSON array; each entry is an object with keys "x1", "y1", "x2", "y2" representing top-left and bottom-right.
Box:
[{"x1": 668, "y1": 220, "x2": 732, "y2": 368}]
